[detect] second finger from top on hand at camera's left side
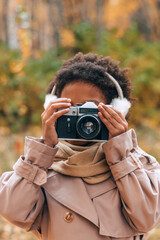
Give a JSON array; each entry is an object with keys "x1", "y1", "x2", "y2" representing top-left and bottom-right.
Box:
[{"x1": 42, "y1": 103, "x2": 71, "y2": 120}]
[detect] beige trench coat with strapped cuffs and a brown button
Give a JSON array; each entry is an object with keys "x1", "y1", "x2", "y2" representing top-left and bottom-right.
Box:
[{"x1": 0, "y1": 129, "x2": 160, "y2": 240}]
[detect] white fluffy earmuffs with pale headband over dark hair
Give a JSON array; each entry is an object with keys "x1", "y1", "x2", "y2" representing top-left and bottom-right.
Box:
[{"x1": 44, "y1": 72, "x2": 131, "y2": 117}]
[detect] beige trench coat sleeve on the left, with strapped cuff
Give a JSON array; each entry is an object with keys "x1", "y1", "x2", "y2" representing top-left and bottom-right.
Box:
[{"x1": 0, "y1": 137, "x2": 57, "y2": 231}]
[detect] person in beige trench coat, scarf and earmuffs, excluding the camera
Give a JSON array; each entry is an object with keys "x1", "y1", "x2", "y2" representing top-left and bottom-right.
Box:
[{"x1": 0, "y1": 53, "x2": 160, "y2": 240}]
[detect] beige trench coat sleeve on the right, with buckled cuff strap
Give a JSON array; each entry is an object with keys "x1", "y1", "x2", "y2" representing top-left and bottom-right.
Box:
[{"x1": 103, "y1": 129, "x2": 160, "y2": 233}]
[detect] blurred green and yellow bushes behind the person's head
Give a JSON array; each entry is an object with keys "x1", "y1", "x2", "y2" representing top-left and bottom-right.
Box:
[{"x1": 0, "y1": 23, "x2": 160, "y2": 131}]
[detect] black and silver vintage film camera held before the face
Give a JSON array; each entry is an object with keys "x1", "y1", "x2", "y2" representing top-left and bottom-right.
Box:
[{"x1": 56, "y1": 102, "x2": 109, "y2": 142}]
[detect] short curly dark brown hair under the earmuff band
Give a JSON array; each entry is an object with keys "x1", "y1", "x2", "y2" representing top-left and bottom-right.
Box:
[{"x1": 46, "y1": 53, "x2": 132, "y2": 104}]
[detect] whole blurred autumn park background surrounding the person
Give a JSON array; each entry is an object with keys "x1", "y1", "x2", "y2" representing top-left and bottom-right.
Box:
[{"x1": 0, "y1": 0, "x2": 160, "y2": 240}]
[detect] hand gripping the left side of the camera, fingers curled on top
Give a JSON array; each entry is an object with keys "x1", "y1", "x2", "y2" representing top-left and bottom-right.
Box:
[{"x1": 41, "y1": 98, "x2": 71, "y2": 147}]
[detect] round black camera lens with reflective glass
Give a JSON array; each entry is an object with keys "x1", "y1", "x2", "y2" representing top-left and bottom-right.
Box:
[{"x1": 76, "y1": 114, "x2": 101, "y2": 140}]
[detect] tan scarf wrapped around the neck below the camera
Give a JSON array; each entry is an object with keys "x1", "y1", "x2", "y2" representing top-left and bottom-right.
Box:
[{"x1": 51, "y1": 141, "x2": 111, "y2": 184}]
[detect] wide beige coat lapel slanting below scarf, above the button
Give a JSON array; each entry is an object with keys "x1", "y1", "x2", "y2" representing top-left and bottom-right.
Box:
[{"x1": 43, "y1": 172, "x2": 98, "y2": 226}]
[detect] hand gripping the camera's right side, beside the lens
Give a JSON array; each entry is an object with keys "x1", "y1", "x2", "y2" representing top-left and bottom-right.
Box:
[{"x1": 98, "y1": 103, "x2": 128, "y2": 139}]
